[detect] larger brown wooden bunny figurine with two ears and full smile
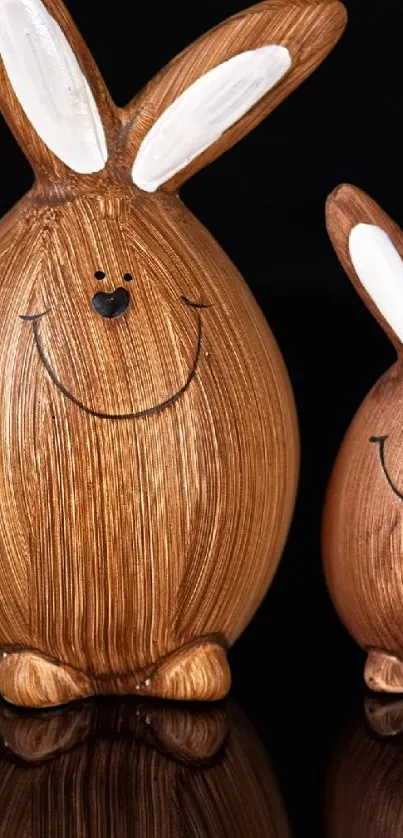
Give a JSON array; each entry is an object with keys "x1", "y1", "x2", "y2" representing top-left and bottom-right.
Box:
[{"x1": 0, "y1": 0, "x2": 345, "y2": 707}]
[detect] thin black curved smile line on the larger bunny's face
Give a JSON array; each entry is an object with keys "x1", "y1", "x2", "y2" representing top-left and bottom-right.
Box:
[{"x1": 20, "y1": 309, "x2": 202, "y2": 420}]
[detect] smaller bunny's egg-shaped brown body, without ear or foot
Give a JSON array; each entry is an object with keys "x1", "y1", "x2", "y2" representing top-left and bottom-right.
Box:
[{"x1": 324, "y1": 361, "x2": 403, "y2": 680}]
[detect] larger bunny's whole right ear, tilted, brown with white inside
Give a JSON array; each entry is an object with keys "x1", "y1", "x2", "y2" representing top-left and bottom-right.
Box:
[{"x1": 124, "y1": 0, "x2": 346, "y2": 192}]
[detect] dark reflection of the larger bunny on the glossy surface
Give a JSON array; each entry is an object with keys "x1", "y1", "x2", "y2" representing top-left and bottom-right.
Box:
[{"x1": 0, "y1": 701, "x2": 290, "y2": 838}]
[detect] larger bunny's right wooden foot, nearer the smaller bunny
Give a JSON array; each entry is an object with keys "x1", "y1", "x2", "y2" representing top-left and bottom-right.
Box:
[{"x1": 138, "y1": 637, "x2": 231, "y2": 701}]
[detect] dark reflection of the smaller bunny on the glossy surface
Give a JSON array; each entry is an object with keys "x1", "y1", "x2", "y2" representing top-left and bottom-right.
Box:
[{"x1": 324, "y1": 712, "x2": 403, "y2": 838}]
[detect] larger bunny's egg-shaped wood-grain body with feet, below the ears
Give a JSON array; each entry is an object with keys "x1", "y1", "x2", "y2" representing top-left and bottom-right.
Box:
[{"x1": 0, "y1": 187, "x2": 298, "y2": 704}]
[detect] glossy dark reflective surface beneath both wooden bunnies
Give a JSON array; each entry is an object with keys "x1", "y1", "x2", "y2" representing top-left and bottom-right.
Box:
[{"x1": 0, "y1": 682, "x2": 403, "y2": 838}]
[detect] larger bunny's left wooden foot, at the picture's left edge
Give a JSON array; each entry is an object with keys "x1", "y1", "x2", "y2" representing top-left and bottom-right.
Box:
[{"x1": 0, "y1": 651, "x2": 93, "y2": 708}]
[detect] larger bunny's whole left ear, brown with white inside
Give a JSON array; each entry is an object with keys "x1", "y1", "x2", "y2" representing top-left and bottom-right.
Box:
[{"x1": 0, "y1": 0, "x2": 115, "y2": 183}]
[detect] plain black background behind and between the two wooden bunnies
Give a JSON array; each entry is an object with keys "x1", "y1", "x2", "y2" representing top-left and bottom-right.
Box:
[{"x1": 0, "y1": 0, "x2": 403, "y2": 835}]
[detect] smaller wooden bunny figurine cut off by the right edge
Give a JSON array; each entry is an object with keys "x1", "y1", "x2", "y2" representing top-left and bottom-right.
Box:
[{"x1": 323, "y1": 185, "x2": 403, "y2": 692}]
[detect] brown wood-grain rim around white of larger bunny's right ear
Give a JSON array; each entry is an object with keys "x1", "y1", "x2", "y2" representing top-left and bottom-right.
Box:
[{"x1": 122, "y1": 0, "x2": 346, "y2": 191}]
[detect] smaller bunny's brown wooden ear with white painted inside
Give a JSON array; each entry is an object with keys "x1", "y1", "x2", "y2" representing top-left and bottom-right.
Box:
[{"x1": 326, "y1": 184, "x2": 403, "y2": 352}]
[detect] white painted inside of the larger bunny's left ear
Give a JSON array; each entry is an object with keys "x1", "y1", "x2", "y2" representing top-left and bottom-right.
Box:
[{"x1": 0, "y1": 0, "x2": 108, "y2": 174}]
